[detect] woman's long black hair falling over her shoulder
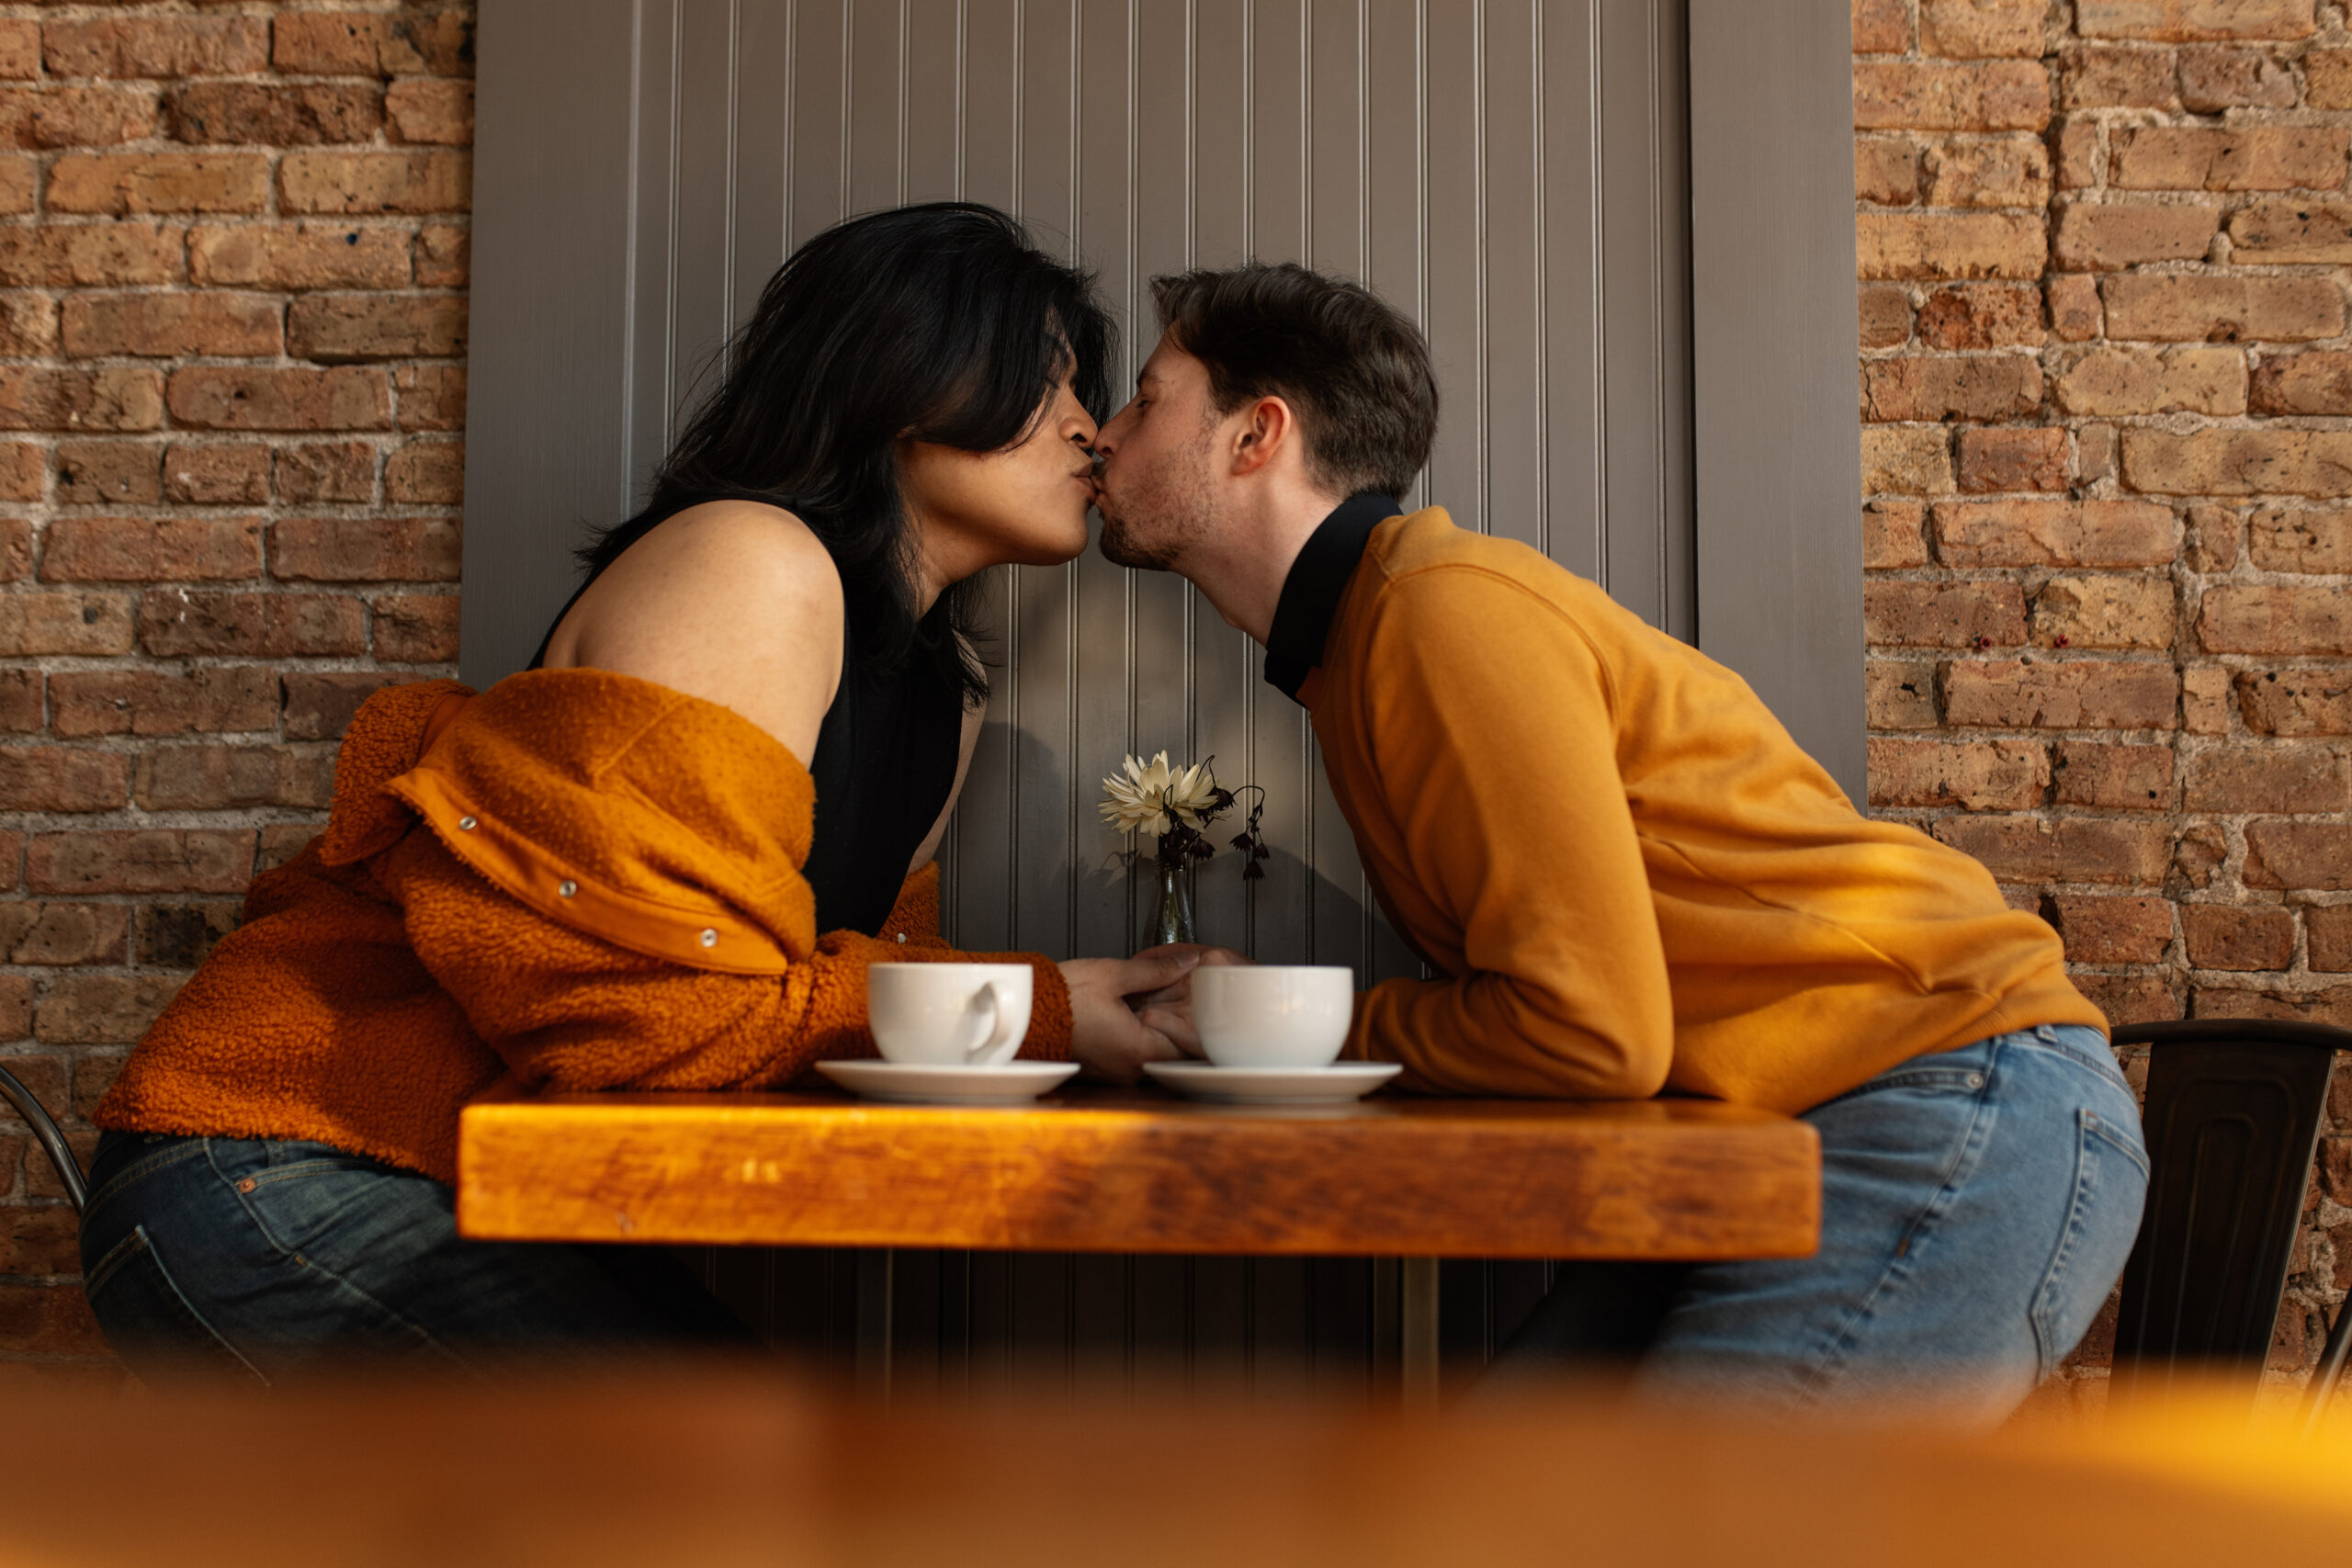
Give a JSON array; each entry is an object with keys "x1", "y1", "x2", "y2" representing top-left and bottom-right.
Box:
[{"x1": 581, "y1": 202, "x2": 1117, "y2": 703}]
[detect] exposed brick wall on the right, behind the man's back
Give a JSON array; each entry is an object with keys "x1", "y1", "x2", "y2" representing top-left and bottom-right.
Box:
[{"x1": 1853, "y1": 0, "x2": 2352, "y2": 1396}]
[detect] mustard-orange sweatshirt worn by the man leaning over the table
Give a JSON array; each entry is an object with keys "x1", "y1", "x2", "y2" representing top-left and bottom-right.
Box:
[{"x1": 1301, "y1": 508, "x2": 2108, "y2": 1112}]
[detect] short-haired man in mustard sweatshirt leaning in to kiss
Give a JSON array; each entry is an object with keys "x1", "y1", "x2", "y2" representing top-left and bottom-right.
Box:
[{"x1": 1096, "y1": 265, "x2": 2147, "y2": 1420}]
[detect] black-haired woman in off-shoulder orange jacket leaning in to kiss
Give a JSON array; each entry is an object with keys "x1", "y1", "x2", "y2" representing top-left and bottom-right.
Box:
[{"x1": 83, "y1": 205, "x2": 1193, "y2": 1380}]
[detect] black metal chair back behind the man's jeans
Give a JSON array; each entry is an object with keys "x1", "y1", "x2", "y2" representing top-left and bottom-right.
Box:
[{"x1": 2114, "y1": 1018, "x2": 2352, "y2": 1438}]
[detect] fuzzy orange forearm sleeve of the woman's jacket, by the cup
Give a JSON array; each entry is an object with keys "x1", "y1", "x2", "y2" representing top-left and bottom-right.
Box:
[{"x1": 371, "y1": 841, "x2": 1070, "y2": 1090}]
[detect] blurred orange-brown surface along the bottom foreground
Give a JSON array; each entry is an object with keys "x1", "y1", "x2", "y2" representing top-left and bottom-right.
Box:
[{"x1": 0, "y1": 1366, "x2": 2352, "y2": 1568}]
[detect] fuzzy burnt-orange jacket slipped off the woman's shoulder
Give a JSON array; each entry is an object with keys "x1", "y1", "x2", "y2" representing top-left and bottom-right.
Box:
[{"x1": 96, "y1": 670, "x2": 1070, "y2": 1182}]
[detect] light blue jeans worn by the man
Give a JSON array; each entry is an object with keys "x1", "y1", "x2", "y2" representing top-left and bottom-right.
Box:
[{"x1": 1477, "y1": 1025, "x2": 2147, "y2": 1422}]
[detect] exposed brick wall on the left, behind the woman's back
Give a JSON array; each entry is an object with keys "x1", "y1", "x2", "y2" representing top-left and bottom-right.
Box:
[{"x1": 0, "y1": 0, "x2": 473, "y2": 1375}]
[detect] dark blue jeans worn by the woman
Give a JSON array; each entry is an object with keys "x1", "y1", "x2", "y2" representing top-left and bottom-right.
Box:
[{"x1": 83, "y1": 1134, "x2": 751, "y2": 1382}]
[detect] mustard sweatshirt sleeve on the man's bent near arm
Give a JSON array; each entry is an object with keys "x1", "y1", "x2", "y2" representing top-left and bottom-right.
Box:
[{"x1": 1350, "y1": 567, "x2": 1675, "y2": 1098}]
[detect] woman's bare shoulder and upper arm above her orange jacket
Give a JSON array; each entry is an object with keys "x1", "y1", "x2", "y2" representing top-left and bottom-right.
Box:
[{"x1": 570, "y1": 501, "x2": 842, "y2": 760}]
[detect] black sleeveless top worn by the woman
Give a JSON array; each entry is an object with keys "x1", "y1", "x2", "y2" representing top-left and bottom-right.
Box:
[{"x1": 529, "y1": 576, "x2": 965, "y2": 936}]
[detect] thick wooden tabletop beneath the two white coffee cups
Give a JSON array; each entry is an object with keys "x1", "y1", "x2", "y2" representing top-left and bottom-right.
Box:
[{"x1": 458, "y1": 1089, "x2": 1820, "y2": 1260}]
